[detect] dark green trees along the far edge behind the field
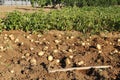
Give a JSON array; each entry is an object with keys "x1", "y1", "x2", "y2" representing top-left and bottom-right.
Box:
[{"x1": 30, "y1": 0, "x2": 120, "y2": 7}]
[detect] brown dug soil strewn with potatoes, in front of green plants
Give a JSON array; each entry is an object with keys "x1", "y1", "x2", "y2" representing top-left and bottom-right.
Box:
[{"x1": 0, "y1": 30, "x2": 120, "y2": 80}]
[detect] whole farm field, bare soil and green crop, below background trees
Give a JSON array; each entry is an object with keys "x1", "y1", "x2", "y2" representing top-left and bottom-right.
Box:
[{"x1": 0, "y1": 6, "x2": 120, "y2": 80}]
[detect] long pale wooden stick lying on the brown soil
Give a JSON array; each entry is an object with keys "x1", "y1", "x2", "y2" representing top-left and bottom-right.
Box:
[{"x1": 48, "y1": 65, "x2": 112, "y2": 73}]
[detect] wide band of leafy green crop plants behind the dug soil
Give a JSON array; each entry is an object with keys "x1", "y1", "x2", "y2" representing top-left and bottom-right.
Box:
[{"x1": 0, "y1": 7, "x2": 120, "y2": 33}]
